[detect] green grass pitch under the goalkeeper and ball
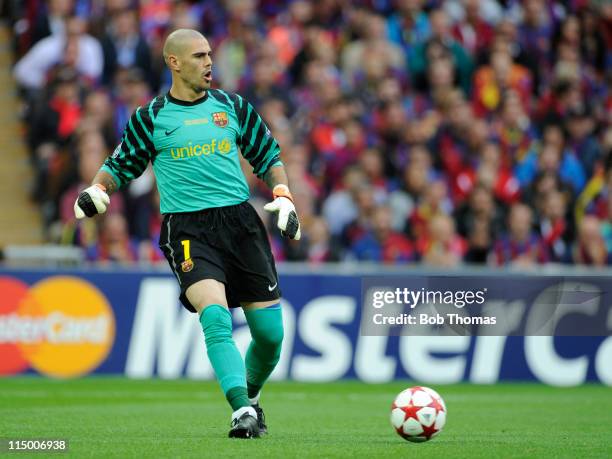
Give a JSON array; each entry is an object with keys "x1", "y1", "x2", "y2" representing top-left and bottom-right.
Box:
[{"x1": 0, "y1": 377, "x2": 612, "y2": 458}]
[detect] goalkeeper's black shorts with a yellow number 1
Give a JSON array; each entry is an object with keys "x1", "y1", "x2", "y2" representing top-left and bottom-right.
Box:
[{"x1": 159, "y1": 202, "x2": 281, "y2": 312}]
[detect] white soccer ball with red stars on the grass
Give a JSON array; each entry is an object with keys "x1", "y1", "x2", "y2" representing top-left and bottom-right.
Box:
[{"x1": 391, "y1": 386, "x2": 446, "y2": 442}]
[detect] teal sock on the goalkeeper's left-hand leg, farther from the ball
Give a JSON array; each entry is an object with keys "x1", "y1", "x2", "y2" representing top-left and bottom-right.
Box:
[{"x1": 200, "y1": 304, "x2": 250, "y2": 411}]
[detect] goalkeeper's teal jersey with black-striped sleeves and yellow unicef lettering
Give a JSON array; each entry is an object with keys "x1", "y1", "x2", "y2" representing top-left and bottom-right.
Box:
[{"x1": 101, "y1": 89, "x2": 281, "y2": 214}]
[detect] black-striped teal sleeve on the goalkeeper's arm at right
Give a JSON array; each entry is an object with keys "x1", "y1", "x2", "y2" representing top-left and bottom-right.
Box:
[{"x1": 232, "y1": 94, "x2": 280, "y2": 178}]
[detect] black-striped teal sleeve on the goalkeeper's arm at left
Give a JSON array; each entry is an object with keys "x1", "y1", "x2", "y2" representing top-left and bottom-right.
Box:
[{"x1": 102, "y1": 104, "x2": 155, "y2": 187}]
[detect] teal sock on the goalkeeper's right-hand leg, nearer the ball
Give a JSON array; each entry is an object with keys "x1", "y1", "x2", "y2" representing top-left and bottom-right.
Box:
[{"x1": 244, "y1": 303, "x2": 283, "y2": 398}]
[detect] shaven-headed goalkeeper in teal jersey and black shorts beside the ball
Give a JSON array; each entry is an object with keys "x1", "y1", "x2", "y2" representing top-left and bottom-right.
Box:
[{"x1": 74, "y1": 29, "x2": 300, "y2": 438}]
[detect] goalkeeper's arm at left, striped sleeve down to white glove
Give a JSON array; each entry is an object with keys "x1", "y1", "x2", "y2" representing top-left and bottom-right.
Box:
[{"x1": 74, "y1": 106, "x2": 155, "y2": 219}]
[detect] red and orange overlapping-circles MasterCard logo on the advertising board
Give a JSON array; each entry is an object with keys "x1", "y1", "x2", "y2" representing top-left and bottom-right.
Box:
[{"x1": 0, "y1": 276, "x2": 115, "y2": 378}]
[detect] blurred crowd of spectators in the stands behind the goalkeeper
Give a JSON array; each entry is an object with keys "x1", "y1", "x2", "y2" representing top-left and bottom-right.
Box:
[{"x1": 5, "y1": 0, "x2": 612, "y2": 267}]
